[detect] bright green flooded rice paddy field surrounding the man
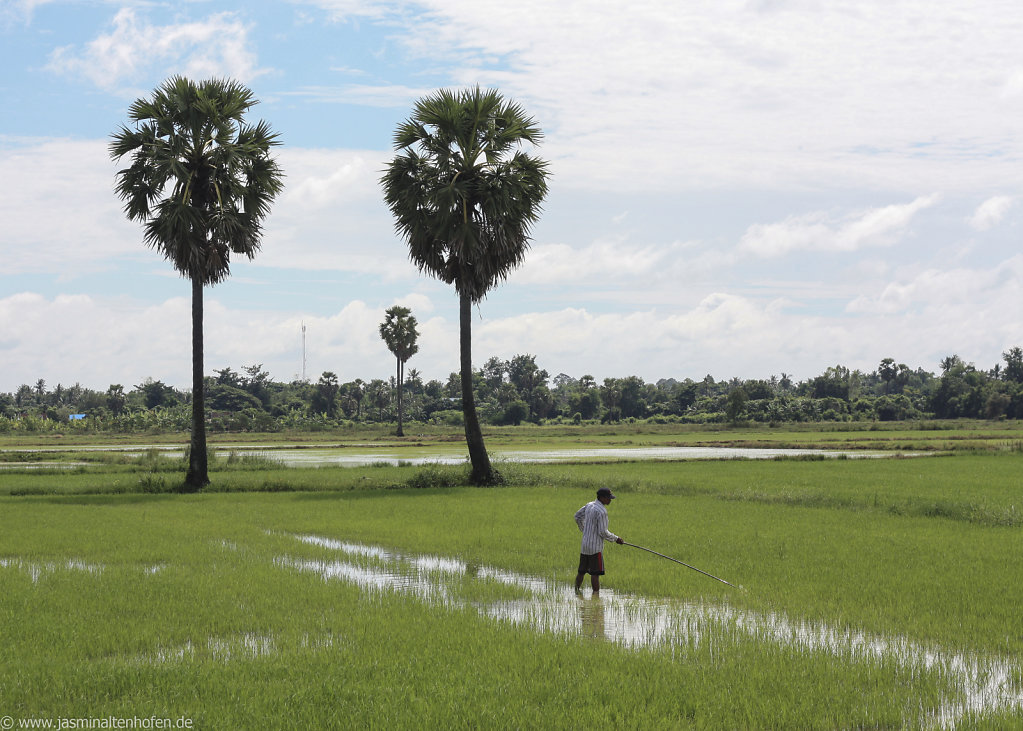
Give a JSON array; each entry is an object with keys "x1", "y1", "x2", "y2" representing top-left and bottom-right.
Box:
[{"x1": 0, "y1": 425, "x2": 1023, "y2": 729}]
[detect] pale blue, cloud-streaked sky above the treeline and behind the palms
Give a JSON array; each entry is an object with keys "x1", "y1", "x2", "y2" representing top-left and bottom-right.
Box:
[{"x1": 0, "y1": 0, "x2": 1023, "y2": 392}]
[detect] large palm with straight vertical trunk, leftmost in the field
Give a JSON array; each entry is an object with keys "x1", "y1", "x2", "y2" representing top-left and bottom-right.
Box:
[{"x1": 109, "y1": 77, "x2": 283, "y2": 490}]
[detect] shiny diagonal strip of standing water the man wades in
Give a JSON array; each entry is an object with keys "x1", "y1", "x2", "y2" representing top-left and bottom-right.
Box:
[{"x1": 274, "y1": 535, "x2": 1023, "y2": 728}]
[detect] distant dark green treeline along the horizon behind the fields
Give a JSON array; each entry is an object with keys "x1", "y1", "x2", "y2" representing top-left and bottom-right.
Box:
[{"x1": 6, "y1": 347, "x2": 1023, "y2": 432}]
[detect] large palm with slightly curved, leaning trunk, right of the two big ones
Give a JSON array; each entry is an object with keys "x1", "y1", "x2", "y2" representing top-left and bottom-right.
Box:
[{"x1": 381, "y1": 87, "x2": 547, "y2": 485}]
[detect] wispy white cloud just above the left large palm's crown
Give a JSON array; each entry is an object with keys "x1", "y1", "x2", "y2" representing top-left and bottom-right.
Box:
[{"x1": 47, "y1": 7, "x2": 266, "y2": 91}]
